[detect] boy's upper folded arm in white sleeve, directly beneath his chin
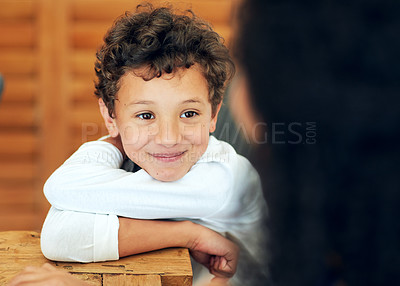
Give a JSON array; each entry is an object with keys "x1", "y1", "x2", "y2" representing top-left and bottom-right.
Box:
[{"x1": 44, "y1": 136, "x2": 232, "y2": 219}]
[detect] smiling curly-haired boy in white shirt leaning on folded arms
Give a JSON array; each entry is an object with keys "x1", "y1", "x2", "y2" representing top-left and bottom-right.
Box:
[{"x1": 41, "y1": 4, "x2": 266, "y2": 285}]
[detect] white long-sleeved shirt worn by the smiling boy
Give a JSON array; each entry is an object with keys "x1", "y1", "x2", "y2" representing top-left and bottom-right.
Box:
[{"x1": 41, "y1": 136, "x2": 266, "y2": 284}]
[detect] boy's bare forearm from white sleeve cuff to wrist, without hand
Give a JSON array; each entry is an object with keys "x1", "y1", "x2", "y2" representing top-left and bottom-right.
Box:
[{"x1": 118, "y1": 217, "x2": 194, "y2": 257}]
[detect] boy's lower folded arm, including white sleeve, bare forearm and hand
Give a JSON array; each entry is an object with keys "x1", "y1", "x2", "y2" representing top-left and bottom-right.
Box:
[{"x1": 41, "y1": 207, "x2": 238, "y2": 277}]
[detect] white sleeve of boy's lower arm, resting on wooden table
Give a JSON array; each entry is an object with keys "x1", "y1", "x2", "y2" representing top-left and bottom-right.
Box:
[{"x1": 40, "y1": 207, "x2": 119, "y2": 262}]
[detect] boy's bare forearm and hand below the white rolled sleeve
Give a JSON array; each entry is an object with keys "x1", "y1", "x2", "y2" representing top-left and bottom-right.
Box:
[{"x1": 118, "y1": 217, "x2": 239, "y2": 278}]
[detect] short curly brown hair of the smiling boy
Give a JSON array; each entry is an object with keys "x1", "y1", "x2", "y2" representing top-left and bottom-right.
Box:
[{"x1": 95, "y1": 4, "x2": 235, "y2": 117}]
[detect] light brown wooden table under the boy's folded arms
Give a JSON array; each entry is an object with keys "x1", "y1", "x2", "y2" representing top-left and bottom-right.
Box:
[{"x1": 0, "y1": 231, "x2": 192, "y2": 286}]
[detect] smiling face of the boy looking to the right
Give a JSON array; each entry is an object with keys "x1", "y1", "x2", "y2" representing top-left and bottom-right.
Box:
[{"x1": 103, "y1": 66, "x2": 218, "y2": 181}]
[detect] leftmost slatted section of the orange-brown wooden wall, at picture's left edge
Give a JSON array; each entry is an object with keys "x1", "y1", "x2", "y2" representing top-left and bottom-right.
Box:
[{"x1": 0, "y1": 0, "x2": 39, "y2": 229}]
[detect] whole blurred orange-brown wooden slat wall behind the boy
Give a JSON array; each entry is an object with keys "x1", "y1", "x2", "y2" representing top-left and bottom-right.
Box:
[{"x1": 0, "y1": 0, "x2": 233, "y2": 231}]
